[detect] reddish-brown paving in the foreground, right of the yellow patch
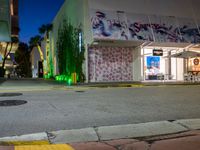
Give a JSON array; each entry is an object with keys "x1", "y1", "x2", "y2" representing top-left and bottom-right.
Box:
[{"x1": 70, "y1": 130, "x2": 200, "y2": 150}]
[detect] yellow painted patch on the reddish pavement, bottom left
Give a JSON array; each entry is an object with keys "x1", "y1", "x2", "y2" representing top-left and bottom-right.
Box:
[{"x1": 15, "y1": 144, "x2": 74, "y2": 150}]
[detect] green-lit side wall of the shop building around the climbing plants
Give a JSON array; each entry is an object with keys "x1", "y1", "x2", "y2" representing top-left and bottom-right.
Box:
[{"x1": 51, "y1": 0, "x2": 93, "y2": 74}]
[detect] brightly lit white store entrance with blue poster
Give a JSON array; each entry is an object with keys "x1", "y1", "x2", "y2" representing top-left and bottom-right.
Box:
[{"x1": 143, "y1": 48, "x2": 184, "y2": 81}]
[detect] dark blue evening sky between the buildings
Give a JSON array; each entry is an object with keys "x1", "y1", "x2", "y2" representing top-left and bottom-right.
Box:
[{"x1": 19, "y1": 0, "x2": 64, "y2": 42}]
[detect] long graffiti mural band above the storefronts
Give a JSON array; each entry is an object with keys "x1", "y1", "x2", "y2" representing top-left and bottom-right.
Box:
[{"x1": 90, "y1": 10, "x2": 200, "y2": 43}]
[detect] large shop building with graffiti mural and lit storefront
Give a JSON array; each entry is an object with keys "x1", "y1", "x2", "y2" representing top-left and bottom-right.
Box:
[{"x1": 50, "y1": 0, "x2": 200, "y2": 82}]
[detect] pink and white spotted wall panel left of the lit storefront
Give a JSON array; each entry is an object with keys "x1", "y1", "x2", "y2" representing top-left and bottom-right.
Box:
[{"x1": 88, "y1": 47, "x2": 133, "y2": 82}]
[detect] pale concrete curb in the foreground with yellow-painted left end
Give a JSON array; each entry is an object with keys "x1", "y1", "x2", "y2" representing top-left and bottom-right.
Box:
[{"x1": 0, "y1": 119, "x2": 200, "y2": 145}]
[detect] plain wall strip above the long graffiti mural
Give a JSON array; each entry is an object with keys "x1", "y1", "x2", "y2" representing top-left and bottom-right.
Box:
[{"x1": 89, "y1": 0, "x2": 200, "y2": 19}]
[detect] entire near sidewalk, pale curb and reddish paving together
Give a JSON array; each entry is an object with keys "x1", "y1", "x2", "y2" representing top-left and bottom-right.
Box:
[{"x1": 0, "y1": 119, "x2": 200, "y2": 150}]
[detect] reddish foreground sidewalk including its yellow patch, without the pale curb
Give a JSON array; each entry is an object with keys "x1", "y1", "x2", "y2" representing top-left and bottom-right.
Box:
[{"x1": 0, "y1": 130, "x2": 200, "y2": 150}]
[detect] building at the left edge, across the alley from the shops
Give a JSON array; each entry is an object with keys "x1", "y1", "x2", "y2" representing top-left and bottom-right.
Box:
[{"x1": 0, "y1": 0, "x2": 19, "y2": 75}]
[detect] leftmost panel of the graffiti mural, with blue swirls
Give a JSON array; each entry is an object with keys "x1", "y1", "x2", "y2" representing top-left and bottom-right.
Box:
[{"x1": 91, "y1": 11, "x2": 130, "y2": 40}]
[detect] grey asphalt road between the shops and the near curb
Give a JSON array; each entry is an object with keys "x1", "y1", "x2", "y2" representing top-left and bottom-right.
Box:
[{"x1": 0, "y1": 80, "x2": 200, "y2": 137}]
